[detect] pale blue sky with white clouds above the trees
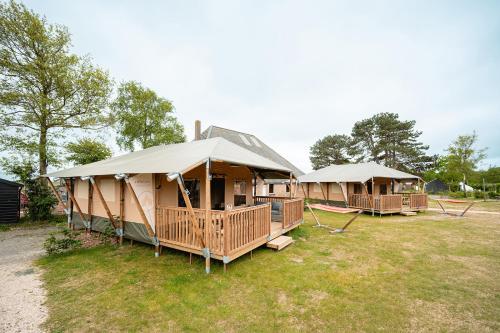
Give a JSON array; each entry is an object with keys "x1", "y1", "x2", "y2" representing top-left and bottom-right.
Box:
[{"x1": 11, "y1": 0, "x2": 500, "y2": 171}]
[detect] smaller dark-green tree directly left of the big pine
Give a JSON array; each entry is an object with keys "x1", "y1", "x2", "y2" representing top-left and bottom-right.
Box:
[{"x1": 309, "y1": 134, "x2": 353, "y2": 170}]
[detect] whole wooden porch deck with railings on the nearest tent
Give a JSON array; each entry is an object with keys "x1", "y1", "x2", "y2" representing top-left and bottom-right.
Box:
[{"x1": 156, "y1": 199, "x2": 304, "y2": 263}]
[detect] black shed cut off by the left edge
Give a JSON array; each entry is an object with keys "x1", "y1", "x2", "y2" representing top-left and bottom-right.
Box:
[{"x1": 0, "y1": 179, "x2": 23, "y2": 223}]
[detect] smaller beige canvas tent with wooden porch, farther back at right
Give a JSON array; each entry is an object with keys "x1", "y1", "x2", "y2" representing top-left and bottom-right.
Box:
[{"x1": 298, "y1": 162, "x2": 427, "y2": 215}]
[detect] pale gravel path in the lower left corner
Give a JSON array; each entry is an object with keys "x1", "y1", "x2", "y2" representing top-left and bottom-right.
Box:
[{"x1": 0, "y1": 227, "x2": 57, "y2": 332}]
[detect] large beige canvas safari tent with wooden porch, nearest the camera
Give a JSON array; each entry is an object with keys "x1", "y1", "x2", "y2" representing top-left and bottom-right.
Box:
[{"x1": 45, "y1": 137, "x2": 304, "y2": 272}]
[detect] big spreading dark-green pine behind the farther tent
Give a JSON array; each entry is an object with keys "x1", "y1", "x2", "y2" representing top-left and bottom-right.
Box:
[{"x1": 351, "y1": 113, "x2": 433, "y2": 173}]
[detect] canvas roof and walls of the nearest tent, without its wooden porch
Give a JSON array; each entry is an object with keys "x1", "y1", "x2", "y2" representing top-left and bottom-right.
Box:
[{"x1": 46, "y1": 138, "x2": 291, "y2": 243}]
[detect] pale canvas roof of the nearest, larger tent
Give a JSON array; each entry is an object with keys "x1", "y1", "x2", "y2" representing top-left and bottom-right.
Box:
[{"x1": 44, "y1": 138, "x2": 291, "y2": 177}]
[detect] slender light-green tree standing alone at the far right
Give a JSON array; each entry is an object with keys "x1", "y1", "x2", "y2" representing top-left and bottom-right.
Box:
[{"x1": 446, "y1": 132, "x2": 486, "y2": 191}]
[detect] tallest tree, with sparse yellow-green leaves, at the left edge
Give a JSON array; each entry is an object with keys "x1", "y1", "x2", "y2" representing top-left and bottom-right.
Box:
[{"x1": 0, "y1": 1, "x2": 111, "y2": 174}]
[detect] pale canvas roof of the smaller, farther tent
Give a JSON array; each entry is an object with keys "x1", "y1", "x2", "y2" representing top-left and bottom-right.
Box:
[{"x1": 299, "y1": 162, "x2": 420, "y2": 183}]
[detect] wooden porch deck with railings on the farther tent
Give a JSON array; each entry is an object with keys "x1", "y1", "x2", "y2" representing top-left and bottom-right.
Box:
[{"x1": 348, "y1": 193, "x2": 428, "y2": 214}]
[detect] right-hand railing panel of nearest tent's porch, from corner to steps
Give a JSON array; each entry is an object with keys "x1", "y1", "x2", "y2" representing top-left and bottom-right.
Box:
[{"x1": 224, "y1": 205, "x2": 271, "y2": 256}]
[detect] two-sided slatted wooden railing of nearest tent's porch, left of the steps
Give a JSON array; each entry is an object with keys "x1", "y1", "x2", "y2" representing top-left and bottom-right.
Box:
[{"x1": 156, "y1": 204, "x2": 271, "y2": 256}]
